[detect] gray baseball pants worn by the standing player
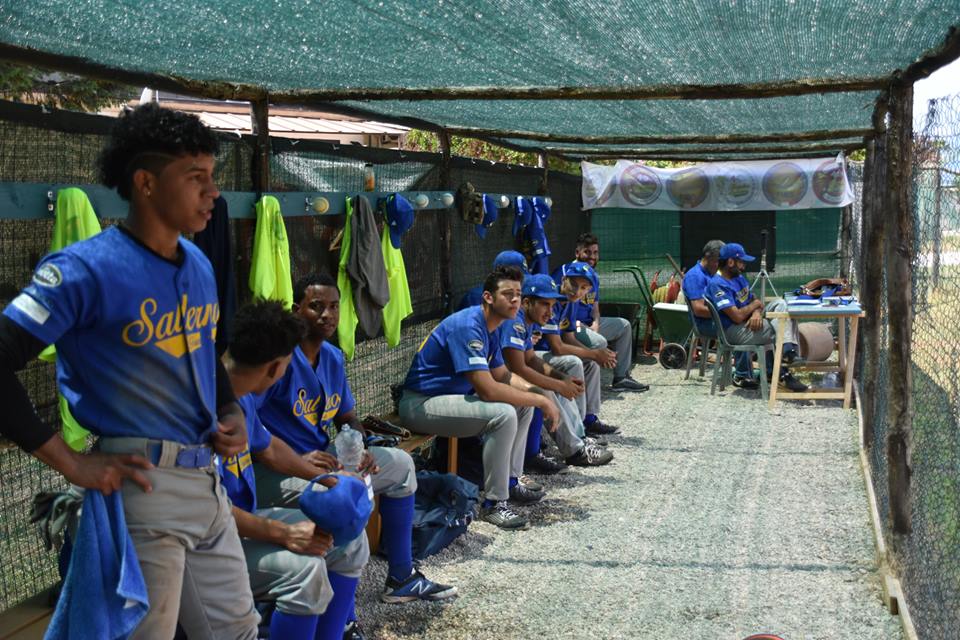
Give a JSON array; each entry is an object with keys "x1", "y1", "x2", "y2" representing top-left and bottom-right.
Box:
[{"x1": 98, "y1": 438, "x2": 260, "y2": 640}]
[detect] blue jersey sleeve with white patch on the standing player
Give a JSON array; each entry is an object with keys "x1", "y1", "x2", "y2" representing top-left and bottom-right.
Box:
[{"x1": 3, "y1": 253, "x2": 97, "y2": 344}]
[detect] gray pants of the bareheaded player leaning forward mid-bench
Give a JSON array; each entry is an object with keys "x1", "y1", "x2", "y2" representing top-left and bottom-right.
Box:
[{"x1": 400, "y1": 390, "x2": 533, "y2": 501}]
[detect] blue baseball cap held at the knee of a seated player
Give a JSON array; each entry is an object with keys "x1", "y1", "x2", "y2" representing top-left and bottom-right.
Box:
[{"x1": 300, "y1": 474, "x2": 373, "y2": 546}]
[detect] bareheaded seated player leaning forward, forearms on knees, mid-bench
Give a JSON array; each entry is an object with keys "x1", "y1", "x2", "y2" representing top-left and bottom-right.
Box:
[{"x1": 400, "y1": 267, "x2": 559, "y2": 529}]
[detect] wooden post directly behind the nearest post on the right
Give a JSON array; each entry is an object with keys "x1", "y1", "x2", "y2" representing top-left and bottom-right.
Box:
[{"x1": 858, "y1": 99, "x2": 887, "y2": 449}]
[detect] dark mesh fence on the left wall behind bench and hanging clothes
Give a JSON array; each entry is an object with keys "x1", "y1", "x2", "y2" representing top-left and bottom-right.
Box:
[{"x1": 0, "y1": 110, "x2": 589, "y2": 612}]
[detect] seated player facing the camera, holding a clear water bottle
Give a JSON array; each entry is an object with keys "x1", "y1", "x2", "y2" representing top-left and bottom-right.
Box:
[{"x1": 258, "y1": 274, "x2": 457, "y2": 603}]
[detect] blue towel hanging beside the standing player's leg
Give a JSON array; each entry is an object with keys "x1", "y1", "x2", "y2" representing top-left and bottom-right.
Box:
[{"x1": 44, "y1": 489, "x2": 150, "y2": 640}]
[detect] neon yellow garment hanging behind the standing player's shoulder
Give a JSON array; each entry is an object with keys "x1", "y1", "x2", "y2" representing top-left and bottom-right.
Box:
[{"x1": 39, "y1": 187, "x2": 101, "y2": 451}]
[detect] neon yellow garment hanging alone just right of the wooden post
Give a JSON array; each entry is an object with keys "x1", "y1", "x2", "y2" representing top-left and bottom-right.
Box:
[{"x1": 250, "y1": 196, "x2": 293, "y2": 309}]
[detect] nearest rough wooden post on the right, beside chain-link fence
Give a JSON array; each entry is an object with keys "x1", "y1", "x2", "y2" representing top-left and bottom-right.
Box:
[{"x1": 884, "y1": 82, "x2": 914, "y2": 534}]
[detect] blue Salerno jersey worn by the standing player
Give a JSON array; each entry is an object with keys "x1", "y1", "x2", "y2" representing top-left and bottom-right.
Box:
[{"x1": 3, "y1": 227, "x2": 220, "y2": 444}]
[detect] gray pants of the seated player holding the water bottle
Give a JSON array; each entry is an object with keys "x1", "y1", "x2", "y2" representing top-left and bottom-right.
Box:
[{"x1": 254, "y1": 444, "x2": 417, "y2": 509}]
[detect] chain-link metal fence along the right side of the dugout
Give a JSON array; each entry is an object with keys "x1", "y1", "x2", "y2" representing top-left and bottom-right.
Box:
[{"x1": 852, "y1": 95, "x2": 960, "y2": 638}]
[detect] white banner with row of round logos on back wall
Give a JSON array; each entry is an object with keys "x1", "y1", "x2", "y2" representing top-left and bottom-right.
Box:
[{"x1": 581, "y1": 155, "x2": 853, "y2": 211}]
